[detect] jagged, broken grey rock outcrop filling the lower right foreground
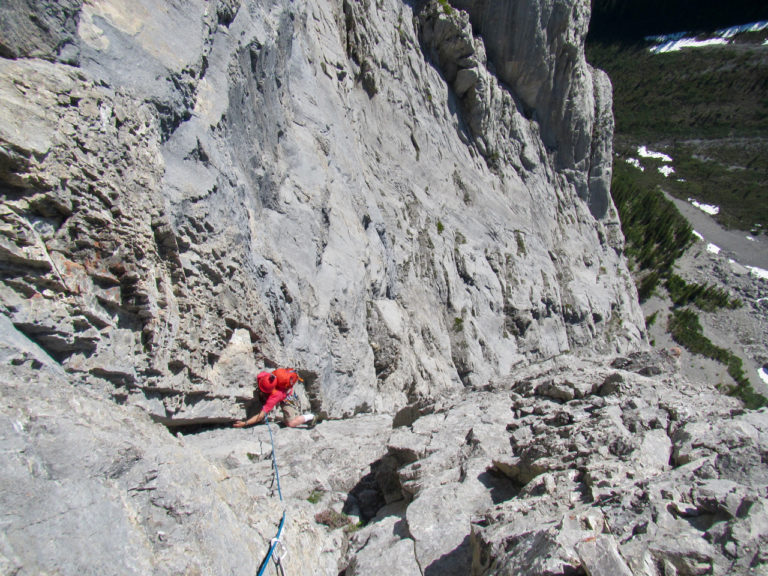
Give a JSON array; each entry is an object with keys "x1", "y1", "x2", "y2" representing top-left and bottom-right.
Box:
[{"x1": 347, "y1": 355, "x2": 768, "y2": 576}]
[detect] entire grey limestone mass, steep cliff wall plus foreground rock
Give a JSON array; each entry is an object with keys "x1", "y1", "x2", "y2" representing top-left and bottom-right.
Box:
[{"x1": 18, "y1": 0, "x2": 768, "y2": 576}]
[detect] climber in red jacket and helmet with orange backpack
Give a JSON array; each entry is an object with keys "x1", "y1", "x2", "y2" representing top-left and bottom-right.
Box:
[{"x1": 233, "y1": 368, "x2": 315, "y2": 428}]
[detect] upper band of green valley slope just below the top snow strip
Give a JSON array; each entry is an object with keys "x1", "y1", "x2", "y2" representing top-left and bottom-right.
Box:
[{"x1": 587, "y1": 43, "x2": 768, "y2": 143}]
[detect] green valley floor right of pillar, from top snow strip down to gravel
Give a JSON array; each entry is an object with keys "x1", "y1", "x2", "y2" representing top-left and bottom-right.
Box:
[{"x1": 587, "y1": 38, "x2": 768, "y2": 234}]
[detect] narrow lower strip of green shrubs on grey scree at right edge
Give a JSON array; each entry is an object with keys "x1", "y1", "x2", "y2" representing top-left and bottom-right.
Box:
[{"x1": 667, "y1": 308, "x2": 768, "y2": 409}]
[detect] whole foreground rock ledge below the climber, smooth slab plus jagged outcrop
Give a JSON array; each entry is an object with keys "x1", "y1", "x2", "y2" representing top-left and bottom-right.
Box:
[{"x1": 0, "y1": 319, "x2": 768, "y2": 576}]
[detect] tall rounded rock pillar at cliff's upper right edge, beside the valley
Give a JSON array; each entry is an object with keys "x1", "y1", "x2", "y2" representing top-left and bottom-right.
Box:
[{"x1": 452, "y1": 0, "x2": 613, "y2": 218}]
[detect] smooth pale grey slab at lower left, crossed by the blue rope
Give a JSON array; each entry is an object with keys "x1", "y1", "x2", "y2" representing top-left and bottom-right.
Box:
[{"x1": 0, "y1": 317, "x2": 390, "y2": 576}]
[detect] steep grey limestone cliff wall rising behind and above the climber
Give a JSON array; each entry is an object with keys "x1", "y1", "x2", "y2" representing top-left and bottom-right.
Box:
[{"x1": 0, "y1": 0, "x2": 644, "y2": 423}]
